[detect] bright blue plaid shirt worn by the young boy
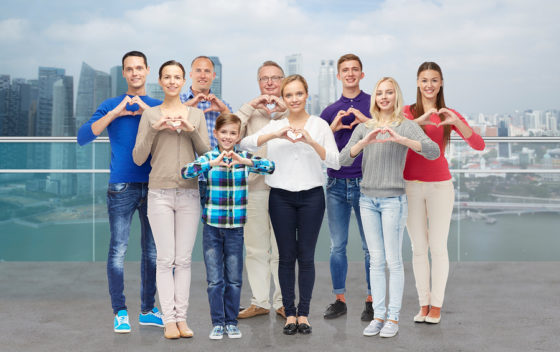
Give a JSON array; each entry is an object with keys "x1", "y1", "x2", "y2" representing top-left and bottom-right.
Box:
[{"x1": 181, "y1": 148, "x2": 275, "y2": 228}]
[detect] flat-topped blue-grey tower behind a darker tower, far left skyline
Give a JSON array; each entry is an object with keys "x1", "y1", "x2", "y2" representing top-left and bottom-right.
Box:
[{"x1": 35, "y1": 67, "x2": 65, "y2": 136}]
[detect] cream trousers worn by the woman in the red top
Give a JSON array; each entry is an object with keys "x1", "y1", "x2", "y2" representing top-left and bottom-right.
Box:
[{"x1": 406, "y1": 180, "x2": 455, "y2": 308}]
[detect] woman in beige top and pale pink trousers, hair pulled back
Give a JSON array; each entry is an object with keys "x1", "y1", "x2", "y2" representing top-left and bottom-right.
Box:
[{"x1": 132, "y1": 60, "x2": 209, "y2": 339}]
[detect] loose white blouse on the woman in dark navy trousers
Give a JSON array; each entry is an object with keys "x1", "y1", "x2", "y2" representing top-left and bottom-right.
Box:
[{"x1": 240, "y1": 115, "x2": 340, "y2": 192}]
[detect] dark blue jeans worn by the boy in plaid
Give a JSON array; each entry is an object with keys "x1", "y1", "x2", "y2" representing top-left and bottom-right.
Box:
[{"x1": 202, "y1": 224, "x2": 243, "y2": 326}]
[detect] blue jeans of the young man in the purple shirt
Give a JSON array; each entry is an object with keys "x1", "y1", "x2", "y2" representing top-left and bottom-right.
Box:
[{"x1": 327, "y1": 177, "x2": 371, "y2": 295}]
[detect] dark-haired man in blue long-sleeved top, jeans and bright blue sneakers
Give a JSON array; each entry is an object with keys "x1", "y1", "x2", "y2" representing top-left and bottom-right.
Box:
[{"x1": 78, "y1": 51, "x2": 163, "y2": 333}]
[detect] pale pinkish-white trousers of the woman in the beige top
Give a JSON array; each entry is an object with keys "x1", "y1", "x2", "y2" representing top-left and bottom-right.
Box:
[{"x1": 148, "y1": 188, "x2": 200, "y2": 323}]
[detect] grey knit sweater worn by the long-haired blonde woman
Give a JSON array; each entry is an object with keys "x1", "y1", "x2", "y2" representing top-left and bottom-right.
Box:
[{"x1": 340, "y1": 119, "x2": 439, "y2": 197}]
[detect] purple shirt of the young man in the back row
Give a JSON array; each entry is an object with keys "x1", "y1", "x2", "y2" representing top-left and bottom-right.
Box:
[{"x1": 321, "y1": 91, "x2": 371, "y2": 178}]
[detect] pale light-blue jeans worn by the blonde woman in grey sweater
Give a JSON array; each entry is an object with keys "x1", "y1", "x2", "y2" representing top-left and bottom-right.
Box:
[{"x1": 360, "y1": 193, "x2": 408, "y2": 321}]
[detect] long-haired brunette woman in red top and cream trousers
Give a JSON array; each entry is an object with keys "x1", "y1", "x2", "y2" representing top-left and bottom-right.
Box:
[{"x1": 403, "y1": 62, "x2": 484, "y2": 323}]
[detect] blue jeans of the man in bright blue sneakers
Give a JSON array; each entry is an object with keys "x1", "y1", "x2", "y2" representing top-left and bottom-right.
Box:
[{"x1": 107, "y1": 183, "x2": 156, "y2": 314}]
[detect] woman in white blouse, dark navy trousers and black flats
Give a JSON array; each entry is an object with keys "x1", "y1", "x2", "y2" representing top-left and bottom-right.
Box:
[{"x1": 241, "y1": 75, "x2": 340, "y2": 335}]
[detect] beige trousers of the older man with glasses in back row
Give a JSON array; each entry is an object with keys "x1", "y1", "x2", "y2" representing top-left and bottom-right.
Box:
[{"x1": 244, "y1": 190, "x2": 282, "y2": 309}]
